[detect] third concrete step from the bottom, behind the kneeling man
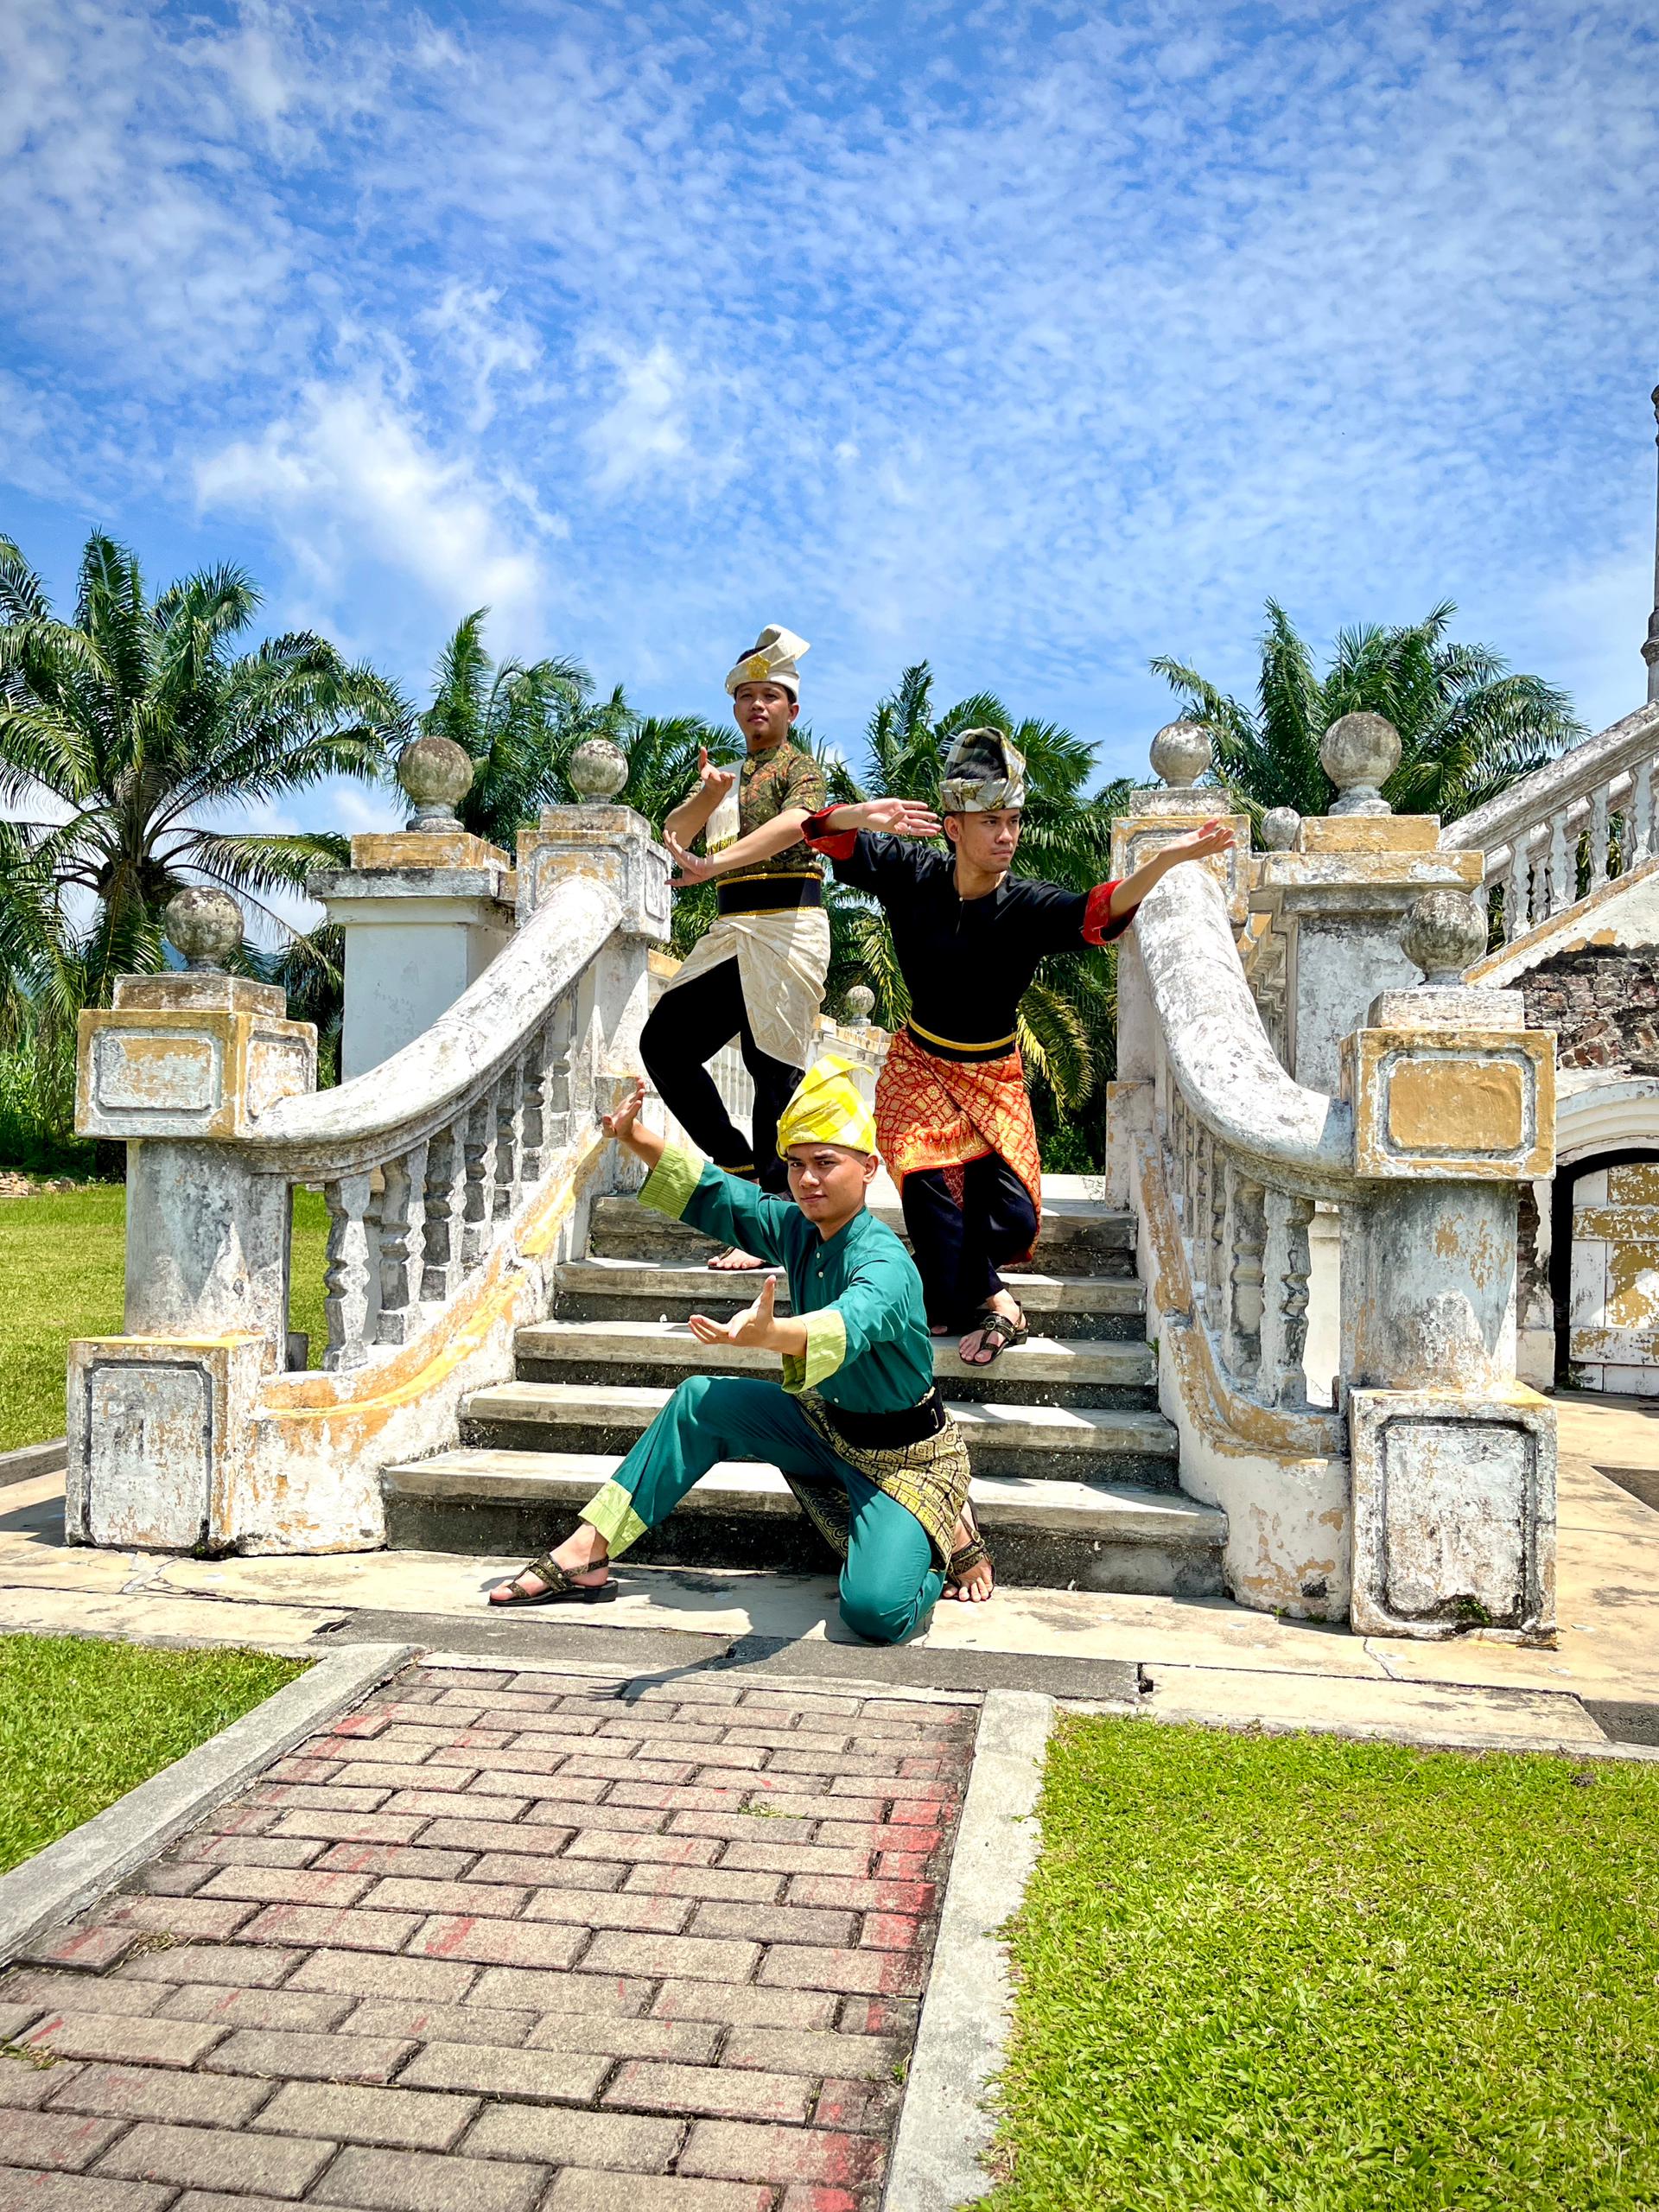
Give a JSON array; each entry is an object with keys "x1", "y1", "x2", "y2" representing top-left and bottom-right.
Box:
[{"x1": 515, "y1": 1318, "x2": 1157, "y2": 1407}]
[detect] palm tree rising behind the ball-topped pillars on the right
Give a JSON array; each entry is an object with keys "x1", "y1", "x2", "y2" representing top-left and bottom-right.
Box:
[{"x1": 1153, "y1": 600, "x2": 1584, "y2": 821}]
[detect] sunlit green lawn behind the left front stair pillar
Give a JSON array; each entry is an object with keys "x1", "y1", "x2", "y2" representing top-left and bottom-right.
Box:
[{"x1": 0, "y1": 1184, "x2": 327, "y2": 1451}]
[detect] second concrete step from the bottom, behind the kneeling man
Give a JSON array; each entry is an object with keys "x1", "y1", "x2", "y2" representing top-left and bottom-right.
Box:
[{"x1": 460, "y1": 1382, "x2": 1177, "y2": 1491}]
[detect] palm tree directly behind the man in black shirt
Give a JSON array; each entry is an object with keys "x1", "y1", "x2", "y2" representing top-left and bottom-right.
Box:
[{"x1": 830, "y1": 661, "x2": 1128, "y2": 1150}]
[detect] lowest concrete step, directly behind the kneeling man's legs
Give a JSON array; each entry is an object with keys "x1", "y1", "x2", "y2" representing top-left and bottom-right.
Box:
[{"x1": 385, "y1": 1451, "x2": 1228, "y2": 1597}]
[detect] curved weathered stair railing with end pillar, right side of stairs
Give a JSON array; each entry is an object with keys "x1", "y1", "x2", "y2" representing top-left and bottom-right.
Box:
[{"x1": 1109, "y1": 747, "x2": 1555, "y2": 1637}]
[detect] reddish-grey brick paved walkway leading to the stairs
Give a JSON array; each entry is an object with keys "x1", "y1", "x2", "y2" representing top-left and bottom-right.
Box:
[{"x1": 0, "y1": 1668, "x2": 976, "y2": 2212}]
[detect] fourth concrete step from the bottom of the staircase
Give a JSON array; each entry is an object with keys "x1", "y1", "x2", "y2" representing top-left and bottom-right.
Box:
[{"x1": 553, "y1": 1256, "x2": 1146, "y2": 1343}]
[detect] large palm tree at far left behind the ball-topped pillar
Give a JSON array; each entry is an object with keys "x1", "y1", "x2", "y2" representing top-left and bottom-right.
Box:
[{"x1": 0, "y1": 531, "x2": 403, "y2": 1065}]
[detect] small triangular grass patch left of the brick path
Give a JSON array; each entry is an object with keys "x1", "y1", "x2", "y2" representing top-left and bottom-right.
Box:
[{"x1": 0, "y1": 1637, "x2": 305, "y2": 1873}]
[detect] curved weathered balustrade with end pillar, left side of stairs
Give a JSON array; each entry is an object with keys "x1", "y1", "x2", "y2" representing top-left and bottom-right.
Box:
[{"x1": 68, "y1": 807, "x2": 671, "y2": 1551}]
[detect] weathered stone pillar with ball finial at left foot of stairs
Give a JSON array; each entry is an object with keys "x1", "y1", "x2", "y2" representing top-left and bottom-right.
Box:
[{"x1": 67, "y1": 889, "x2": 316, "y2": 1551}]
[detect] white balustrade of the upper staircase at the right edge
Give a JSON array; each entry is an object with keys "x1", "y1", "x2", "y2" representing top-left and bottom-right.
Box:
[{"x1": 1440, "y1": 703, "x2": 1659, "y2": 944}]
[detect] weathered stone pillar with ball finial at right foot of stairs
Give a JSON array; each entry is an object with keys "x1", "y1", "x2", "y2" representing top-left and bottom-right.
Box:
[{"x1": 1343, "y1": 892, "x2": 1555, "y2": 1635}]
